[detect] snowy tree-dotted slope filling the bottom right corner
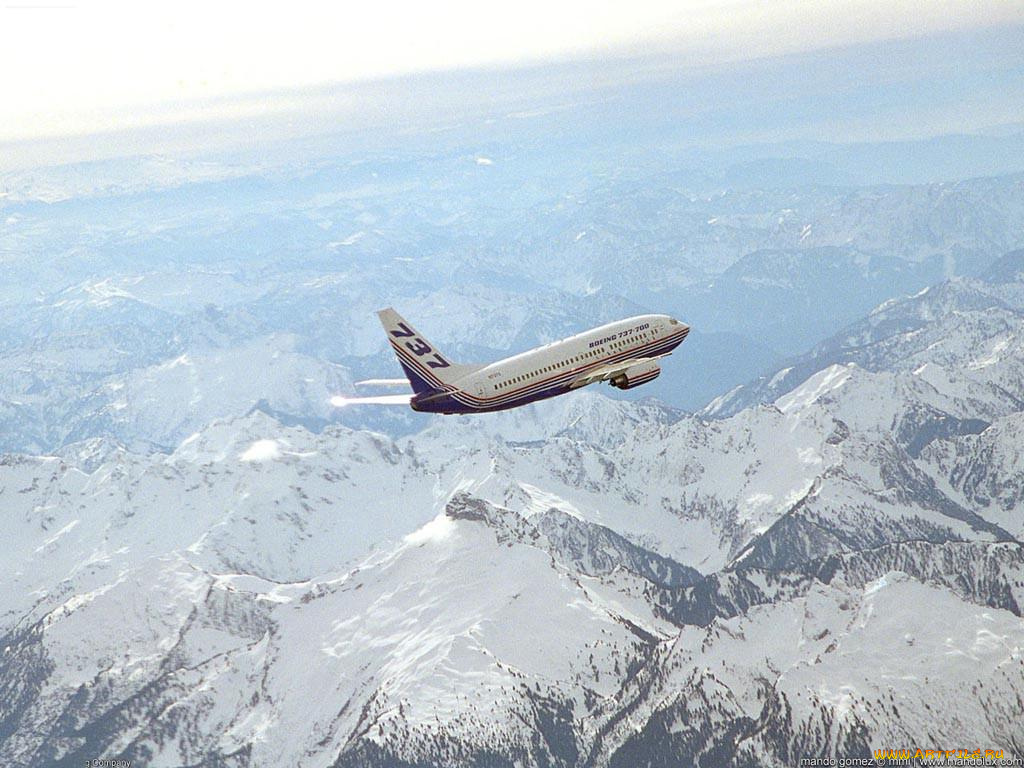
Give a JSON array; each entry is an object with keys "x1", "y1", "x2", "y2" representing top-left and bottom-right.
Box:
[{"x1": 593, "y1": 566, "x2": 1024, "y2": 766}]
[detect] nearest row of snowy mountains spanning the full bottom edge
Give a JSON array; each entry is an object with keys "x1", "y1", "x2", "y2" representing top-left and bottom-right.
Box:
[{"x1": 0, "y1": 495, "x2": 1024, "y2": 766}]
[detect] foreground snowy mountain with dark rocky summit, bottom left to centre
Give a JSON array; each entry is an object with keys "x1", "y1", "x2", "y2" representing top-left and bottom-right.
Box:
[{"x1": 2, "y1": 497, "x2": 672, "y2": 766}]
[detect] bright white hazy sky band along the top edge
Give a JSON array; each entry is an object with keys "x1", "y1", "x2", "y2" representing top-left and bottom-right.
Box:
[{"x1": 0, "y1": 0, "x2": 1024, "y2": 141}]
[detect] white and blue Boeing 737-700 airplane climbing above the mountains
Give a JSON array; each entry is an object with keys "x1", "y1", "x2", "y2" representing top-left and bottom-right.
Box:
[{"x1": 377, "y1": 307, "x2": 690, "y2": 414}]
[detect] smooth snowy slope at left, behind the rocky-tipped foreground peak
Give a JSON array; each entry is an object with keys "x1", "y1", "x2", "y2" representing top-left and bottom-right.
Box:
[{"x1": 0, "y1": 412, "x2": 444, "y2": 627}]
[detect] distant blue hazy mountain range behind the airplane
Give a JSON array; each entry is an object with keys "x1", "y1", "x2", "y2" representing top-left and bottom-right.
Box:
[{"x1": 0, "y1": 146, "x2": 1024, "y2": 453}]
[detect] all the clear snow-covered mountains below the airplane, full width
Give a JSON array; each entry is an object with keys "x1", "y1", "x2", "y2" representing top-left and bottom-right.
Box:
[{"x1": 0, "y1": 256, "x2": 1024, "y2": 767}]
